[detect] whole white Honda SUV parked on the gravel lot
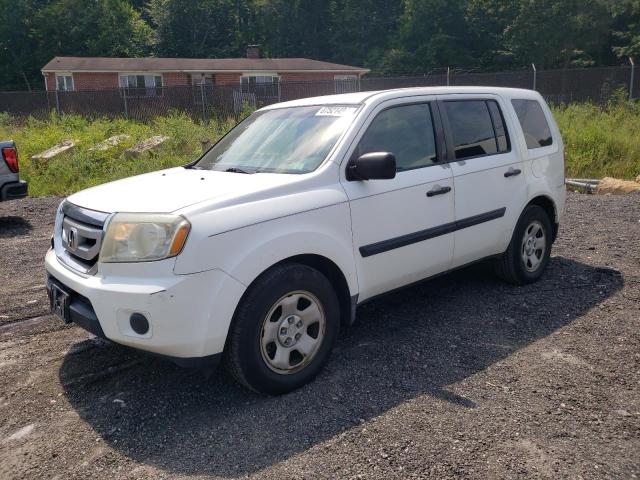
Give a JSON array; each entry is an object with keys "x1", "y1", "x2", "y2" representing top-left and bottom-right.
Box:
[{"x1": 46, "y1": 87, "x2": 565, "y2": 394}]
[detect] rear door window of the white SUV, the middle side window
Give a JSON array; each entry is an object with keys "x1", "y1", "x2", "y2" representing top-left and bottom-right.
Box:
[{"x1": 444, "y1": 100, "x2": 510, "y2": 160}]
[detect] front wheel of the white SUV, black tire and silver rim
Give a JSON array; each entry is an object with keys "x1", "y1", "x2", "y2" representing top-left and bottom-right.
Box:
[{"x1": 224, "y1": 263, "x2": 340, "y2": 395}]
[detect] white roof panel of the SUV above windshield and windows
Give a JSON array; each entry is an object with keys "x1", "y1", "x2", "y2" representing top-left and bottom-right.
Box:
[{"x1": 263, "y1": 87, "x2": 540, "y2": 110}]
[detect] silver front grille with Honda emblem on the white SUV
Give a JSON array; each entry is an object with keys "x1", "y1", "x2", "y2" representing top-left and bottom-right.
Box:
[{"x1": 57, "y1": 202, "x2": 109, "y2": 274}]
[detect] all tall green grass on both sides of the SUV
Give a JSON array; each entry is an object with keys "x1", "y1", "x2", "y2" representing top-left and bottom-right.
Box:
[{"x1": 0, "y1": 101, "x2": 640, "y2": 196}]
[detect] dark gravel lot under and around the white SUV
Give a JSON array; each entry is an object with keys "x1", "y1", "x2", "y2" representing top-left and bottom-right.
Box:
[{"x1": 0, "y1": 194, "x2": 640, "y2": 479}]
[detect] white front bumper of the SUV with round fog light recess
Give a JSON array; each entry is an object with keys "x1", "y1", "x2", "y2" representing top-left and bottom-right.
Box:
[{"x1": 45, "y1": 250, "x2": 245, "y2": 364}]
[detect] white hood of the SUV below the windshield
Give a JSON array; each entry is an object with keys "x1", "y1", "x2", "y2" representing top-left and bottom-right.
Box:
[{"x1": 68, "y1": 167, "x2": 296, "y2": 213}]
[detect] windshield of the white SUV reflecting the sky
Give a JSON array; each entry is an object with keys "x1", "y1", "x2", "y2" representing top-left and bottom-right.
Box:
[{"x1": 194, "y1": 105, "x2": 358, "y2": 173}]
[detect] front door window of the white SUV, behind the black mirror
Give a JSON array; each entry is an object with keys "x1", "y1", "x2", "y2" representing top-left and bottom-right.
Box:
[{"x1": 354, "y1": 104, "x2": 437, "y2": 172}]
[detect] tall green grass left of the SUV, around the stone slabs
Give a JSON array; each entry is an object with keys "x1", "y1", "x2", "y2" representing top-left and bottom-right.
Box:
[{"x1": 0, "y1": 113, "x2": 239, "y2": 196}]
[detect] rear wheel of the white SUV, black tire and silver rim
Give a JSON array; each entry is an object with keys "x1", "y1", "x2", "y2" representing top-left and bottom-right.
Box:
[{"x1": 496, "y1": 205, "x2": 553, "y2": 285}]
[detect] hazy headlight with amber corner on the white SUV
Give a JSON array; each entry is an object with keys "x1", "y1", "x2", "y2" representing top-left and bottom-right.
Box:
[{"x1": 100, "y1": 213, "x2": 191, "y2": 263}]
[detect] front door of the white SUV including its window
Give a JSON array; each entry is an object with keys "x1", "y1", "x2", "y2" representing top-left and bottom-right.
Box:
[{"x1": 343, "y1": 97, "x2": 454, "y2": 300}]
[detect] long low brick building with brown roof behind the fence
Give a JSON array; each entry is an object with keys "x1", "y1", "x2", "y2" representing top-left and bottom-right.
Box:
[{"x1": 42, "y1": 47, "x2": 369, "y2": 97}]
